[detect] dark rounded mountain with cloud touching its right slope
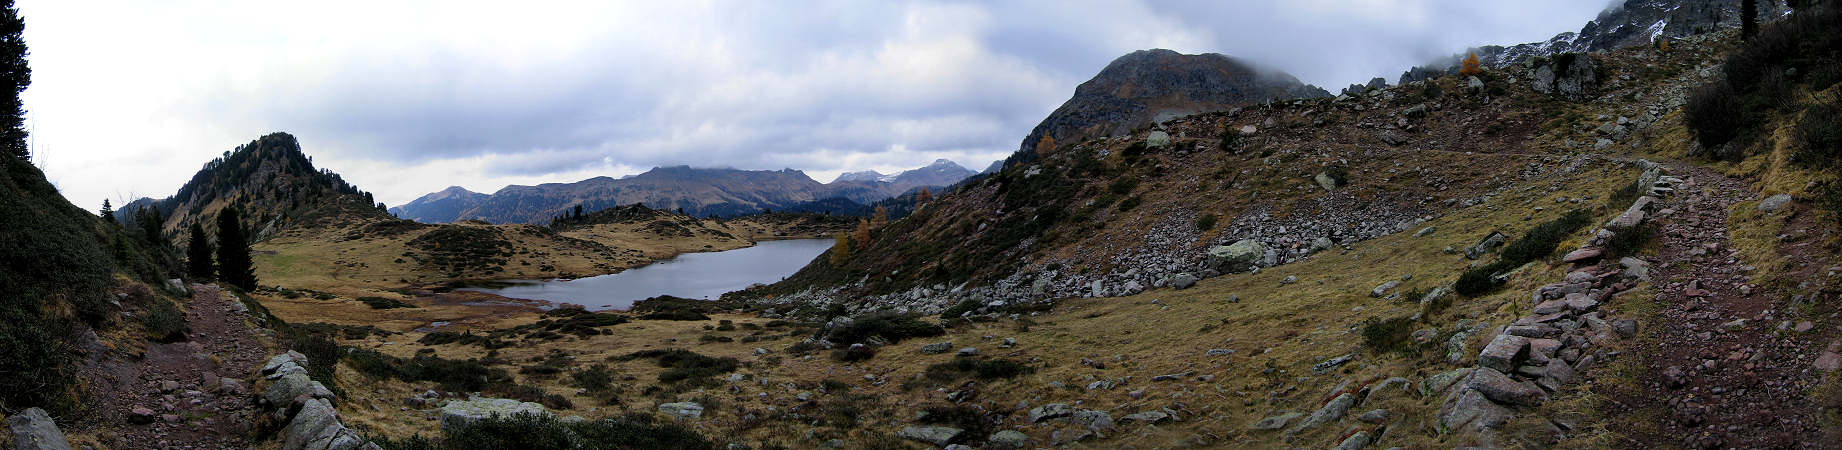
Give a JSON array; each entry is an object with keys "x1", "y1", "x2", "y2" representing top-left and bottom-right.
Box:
[{"x1": 1019, "y1": 48, "x2": 1330, "y2": 159}]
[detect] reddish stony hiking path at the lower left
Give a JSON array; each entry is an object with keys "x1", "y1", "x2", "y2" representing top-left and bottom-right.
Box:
[{"x1": 92, "y1": 284, "x2": 267, "y2": 448}]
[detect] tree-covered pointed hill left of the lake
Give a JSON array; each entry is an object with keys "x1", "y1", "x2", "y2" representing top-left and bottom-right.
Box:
[{"x1": 116, "y1": 133, "x2": 389, "y2": 238}]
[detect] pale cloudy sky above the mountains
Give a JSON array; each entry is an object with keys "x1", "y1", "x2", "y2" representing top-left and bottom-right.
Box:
[{"x1": 18, "y1": 0, "x2": 1608, "y2": 207}]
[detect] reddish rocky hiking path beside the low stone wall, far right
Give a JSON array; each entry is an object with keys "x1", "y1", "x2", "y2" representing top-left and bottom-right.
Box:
[{"x1": 1614, "y1": 164, "x2": 1831, "y2": 448}]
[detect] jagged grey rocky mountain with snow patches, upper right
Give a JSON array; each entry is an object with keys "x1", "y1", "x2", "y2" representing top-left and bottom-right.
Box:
[{"x1": 1400, "y1": 0, "x2": 1790, "y2": 83}]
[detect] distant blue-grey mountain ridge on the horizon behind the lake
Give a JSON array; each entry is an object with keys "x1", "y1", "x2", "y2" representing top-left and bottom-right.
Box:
[{"x1": 391, "y1": 159, "x2": 976, "y2": 223}]
